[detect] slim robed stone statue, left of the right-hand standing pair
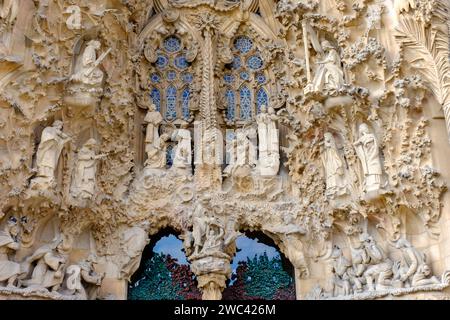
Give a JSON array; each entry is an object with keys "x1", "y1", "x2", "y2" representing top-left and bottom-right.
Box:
[{"x1": 322, "y1": 132, "x2": 347, "y2": 198}]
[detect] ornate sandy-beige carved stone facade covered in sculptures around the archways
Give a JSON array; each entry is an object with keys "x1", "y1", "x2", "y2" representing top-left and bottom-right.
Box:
[{"x1": 0, "y1": 0, "x2": 450, "y2": 300}]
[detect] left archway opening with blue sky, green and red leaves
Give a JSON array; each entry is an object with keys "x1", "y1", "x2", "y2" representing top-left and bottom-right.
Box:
[{"x1": 128, "y1": 229, "x2": 201, "y2": 300}]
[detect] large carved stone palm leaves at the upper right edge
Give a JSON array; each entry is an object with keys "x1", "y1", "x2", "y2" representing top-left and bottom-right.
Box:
[{"x1": 396, "y1": 17, "x2": 450, "y2": 106}]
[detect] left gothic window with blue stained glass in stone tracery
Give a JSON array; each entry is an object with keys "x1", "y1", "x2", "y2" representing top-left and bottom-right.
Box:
[{"x1": 150, "y1": 35, "x2": 194, "y2": 122}]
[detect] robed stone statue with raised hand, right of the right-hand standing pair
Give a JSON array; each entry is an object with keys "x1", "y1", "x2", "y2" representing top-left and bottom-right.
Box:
[{"x1": 355, "y1": 123, "x2": 382, "y2": 193}]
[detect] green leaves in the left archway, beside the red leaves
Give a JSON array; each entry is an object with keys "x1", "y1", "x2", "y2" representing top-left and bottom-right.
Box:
[{"x1": 128, "y1": 253, "x2": 183, "y2": 300}]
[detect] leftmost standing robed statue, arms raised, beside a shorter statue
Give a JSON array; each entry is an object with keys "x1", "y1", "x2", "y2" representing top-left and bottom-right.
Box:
[{"x1": 31, "y1": 121, "x2": 71, "y2": 189}]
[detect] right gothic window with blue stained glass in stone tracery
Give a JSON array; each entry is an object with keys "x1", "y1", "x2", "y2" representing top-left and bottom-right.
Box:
[{"x1": 222, "y1": 35, "x2": 270, "y2": 122}]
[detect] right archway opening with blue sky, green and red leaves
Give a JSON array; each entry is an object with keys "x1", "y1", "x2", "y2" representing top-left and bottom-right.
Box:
[{"x1": 223, "y1": 232, "x2": 296, "y2": 300}]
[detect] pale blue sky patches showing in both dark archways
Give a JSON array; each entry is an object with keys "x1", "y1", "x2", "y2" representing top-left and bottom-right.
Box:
[{"x1": 153, "y1": 235, "x2": 280, "y2": 272}]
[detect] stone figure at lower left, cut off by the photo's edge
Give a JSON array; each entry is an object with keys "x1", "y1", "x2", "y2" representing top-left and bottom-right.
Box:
[{"x1": 0, "y1": 217, "x2": 21, "y2": 287}]
